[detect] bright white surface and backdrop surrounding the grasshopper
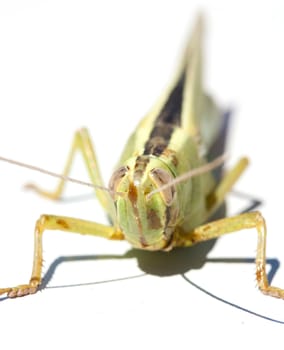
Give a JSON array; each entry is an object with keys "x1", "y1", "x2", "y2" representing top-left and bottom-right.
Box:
[{"x1": 0, "y1": 0, "x2": 284, "y2": 349}]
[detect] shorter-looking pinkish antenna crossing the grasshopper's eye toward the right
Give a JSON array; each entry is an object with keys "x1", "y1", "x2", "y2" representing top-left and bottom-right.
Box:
[{"x1": 147, "y1": 154, "x2": 228, "y2": 199}]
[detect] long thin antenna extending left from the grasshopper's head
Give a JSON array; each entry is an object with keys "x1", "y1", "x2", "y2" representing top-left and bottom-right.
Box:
[{"x1": 0, "y1": 156, "x2": 123, "y2": 196}]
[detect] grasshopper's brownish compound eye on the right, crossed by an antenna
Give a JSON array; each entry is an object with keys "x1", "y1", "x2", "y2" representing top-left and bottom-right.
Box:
[{"x1": 150, "y1": 168, "x2": 176, "y2": 206}]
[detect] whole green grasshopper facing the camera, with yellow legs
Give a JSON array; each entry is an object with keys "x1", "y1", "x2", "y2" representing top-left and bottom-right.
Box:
[{"x1": 0, "y1": 15, "x2": 284, "y2": 298}]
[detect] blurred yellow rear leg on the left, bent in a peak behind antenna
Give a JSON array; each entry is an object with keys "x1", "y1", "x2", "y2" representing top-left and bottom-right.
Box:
[{"x1": 26, "y1": 128, "x2": 110, "y2": 210}]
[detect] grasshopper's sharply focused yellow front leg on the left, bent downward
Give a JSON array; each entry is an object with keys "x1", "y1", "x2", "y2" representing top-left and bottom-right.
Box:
[{"x1": 0, "y1": 215, "x2": 124, "y2": 298}]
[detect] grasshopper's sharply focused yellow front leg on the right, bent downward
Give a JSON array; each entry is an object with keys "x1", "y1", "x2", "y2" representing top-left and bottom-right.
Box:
[{"x1": 175, "y1": 212, "x2": 284, "y2": 299}]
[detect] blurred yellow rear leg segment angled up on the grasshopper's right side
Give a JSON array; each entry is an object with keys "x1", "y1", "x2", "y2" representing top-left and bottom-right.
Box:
[{"x1": 207, "y1": 158, "x2": 248, "y2": 218}]
